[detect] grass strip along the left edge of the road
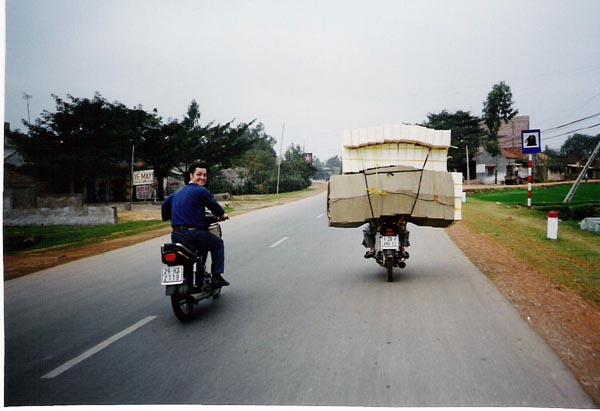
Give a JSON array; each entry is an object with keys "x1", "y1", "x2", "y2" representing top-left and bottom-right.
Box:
[{"x1": 3, "y1": 220, "x2": 168, "y2": 255}]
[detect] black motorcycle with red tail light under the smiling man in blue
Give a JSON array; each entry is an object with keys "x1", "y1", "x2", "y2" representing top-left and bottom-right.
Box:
[{"x1": 160, "y1": 218, "x2": 222, "y2": 322}]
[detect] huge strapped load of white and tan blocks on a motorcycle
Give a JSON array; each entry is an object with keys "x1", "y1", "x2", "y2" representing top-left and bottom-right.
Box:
[{"x1": 327, "y1": 124, "x2": 462, "y2": 227}]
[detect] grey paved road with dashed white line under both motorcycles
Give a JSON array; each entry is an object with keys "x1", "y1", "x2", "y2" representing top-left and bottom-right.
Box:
[{"x1": 4, "y1": 195, "x2": 594, "y2": 408}]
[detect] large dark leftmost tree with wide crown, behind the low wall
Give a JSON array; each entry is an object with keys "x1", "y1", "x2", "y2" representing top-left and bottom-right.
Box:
[{"x1": 13, "y1": 93, "x2": 146, "y2": 199}]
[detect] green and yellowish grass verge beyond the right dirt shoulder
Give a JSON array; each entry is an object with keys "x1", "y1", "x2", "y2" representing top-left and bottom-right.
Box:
[{"x1": 461, "y1": 190, "x2": 600, "y2": 306}]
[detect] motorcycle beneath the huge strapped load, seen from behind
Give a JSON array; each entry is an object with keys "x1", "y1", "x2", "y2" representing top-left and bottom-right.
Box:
[{"x1": 375, "y1": 216, "x2": 410, "y2": 282}]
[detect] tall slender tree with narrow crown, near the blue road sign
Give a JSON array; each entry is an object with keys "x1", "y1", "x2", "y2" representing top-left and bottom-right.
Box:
[{"x1": 482, "y1": 81, "x2": 519, "y2": 157}]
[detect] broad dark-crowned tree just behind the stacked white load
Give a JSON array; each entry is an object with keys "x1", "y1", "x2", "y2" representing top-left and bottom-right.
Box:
[{"x1": 422, "y1": 110, "x2": 484, "y2": 178}]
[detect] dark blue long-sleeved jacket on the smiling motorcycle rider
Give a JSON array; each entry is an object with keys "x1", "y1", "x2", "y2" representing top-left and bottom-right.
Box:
[{"x1": 161, "y1": 183, "x2": 225, "y2": 229}]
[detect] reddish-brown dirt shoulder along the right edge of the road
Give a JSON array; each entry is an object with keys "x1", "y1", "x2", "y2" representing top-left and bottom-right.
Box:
[{"x1": 446, "y1": 223, "x2": 600, "y2": 406}]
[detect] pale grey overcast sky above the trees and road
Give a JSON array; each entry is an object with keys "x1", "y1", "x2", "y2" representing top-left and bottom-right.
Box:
[{"x1": 5, "y1": 0, "x2": 600, "y2": 161}]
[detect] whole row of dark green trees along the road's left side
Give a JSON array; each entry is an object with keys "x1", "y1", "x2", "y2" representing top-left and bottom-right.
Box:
[{"x1": 7, "y1": 93, "x2": 312, "y2": 202}]
